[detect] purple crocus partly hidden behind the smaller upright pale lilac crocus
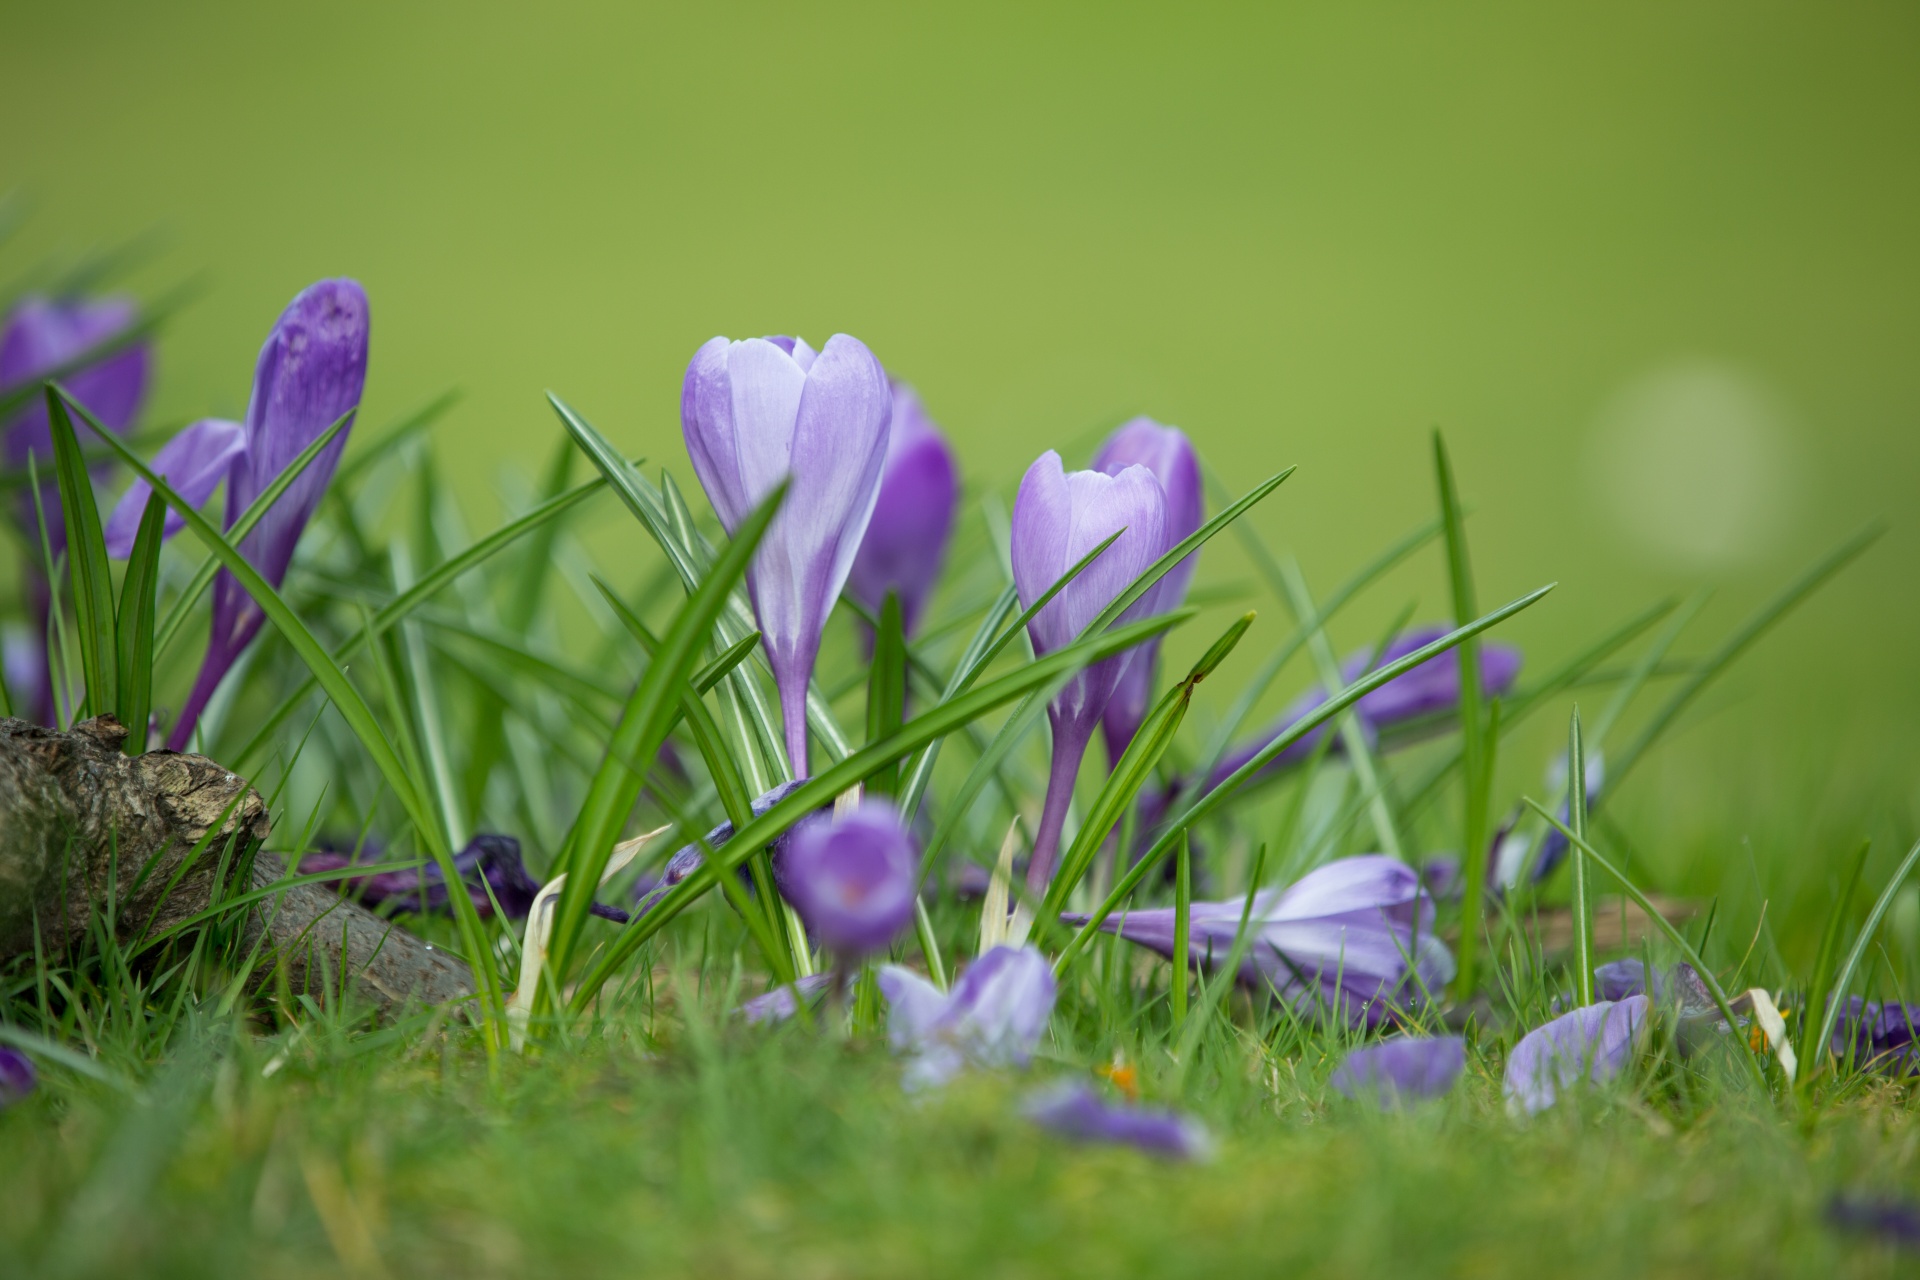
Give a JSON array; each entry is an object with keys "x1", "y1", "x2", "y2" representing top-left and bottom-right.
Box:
[{"x1": 1092, "y1": 418, "x2": 1206, "y2": 764}]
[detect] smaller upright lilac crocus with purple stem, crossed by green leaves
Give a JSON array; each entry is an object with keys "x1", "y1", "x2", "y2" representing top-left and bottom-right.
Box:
[{"x1": 1012, "y1": 449, "x2": 1167, "y2": 892}]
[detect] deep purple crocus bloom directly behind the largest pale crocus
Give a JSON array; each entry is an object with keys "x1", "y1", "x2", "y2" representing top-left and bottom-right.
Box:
[{"x1": 847, "y1": 382, "x2": 960, "y2": 635}]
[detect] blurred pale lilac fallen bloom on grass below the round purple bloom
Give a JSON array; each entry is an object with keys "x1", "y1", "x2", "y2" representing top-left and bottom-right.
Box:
[{"x1": 879, "y1": 946, "x2": 1060, "y2": 1088}]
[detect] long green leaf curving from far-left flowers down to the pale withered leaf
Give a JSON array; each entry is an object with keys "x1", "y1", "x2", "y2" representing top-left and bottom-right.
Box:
[{"x1": 61, "y1": 391, "x2": 505, "y2": 1055}]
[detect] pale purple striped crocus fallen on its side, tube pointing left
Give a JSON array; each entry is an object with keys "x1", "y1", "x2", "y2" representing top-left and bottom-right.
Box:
[{"x1": 1060, "y1": 854, "x2": 1453, "y2": 1025}]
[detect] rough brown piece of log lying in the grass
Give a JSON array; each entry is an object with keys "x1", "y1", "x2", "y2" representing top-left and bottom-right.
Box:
[{"x1": 0, "y1": 716, "x2": 472, "y2": 1013}]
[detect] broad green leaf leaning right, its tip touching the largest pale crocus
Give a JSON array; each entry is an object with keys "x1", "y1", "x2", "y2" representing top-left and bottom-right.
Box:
[{"x1": 536, "y1": 482, "x2": 787, "y2": 990}]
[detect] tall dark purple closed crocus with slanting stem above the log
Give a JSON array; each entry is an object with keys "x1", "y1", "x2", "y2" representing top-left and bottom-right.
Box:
[{"x1": 167, "y1": 278, "x2": 369, "y2": 750}]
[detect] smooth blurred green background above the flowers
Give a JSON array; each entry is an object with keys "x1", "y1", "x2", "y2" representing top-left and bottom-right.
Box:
[{"x1": 0, "y1": 0, "x2": 1920, "y2": 852}]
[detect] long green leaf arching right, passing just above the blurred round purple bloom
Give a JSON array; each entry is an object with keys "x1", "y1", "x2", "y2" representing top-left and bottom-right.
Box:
[{"x1": 572, "y1": 610, "x2": 1192, "y2": 1009}]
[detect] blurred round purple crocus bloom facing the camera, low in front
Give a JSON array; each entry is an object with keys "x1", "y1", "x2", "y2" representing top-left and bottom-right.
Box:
[{"x1": 781, "y1": 800, "x2": 920, "y2": 960}]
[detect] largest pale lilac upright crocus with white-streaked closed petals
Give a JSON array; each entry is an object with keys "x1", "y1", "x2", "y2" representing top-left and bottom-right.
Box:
[{"x1": 680, "y1": 334, "x2": 893, "y2": 777}]
